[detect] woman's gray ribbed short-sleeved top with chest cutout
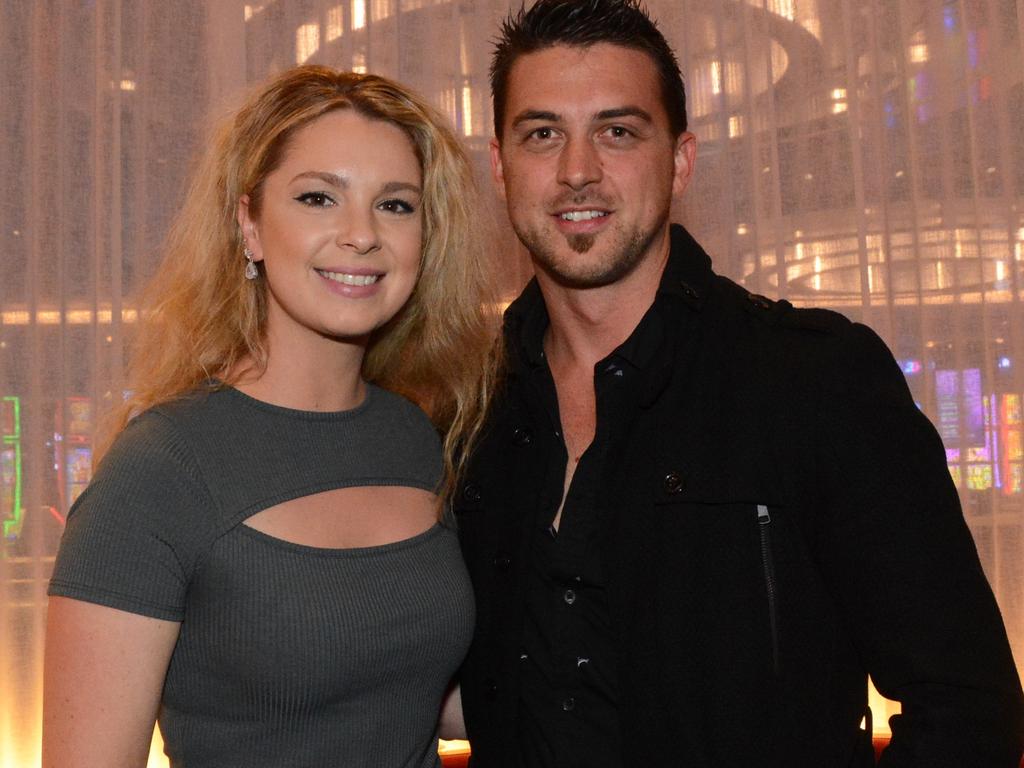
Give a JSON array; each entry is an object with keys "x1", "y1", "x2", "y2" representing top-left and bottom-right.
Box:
[{"x1": 50, "y1": 387, "x2": 473, "y2": 768}]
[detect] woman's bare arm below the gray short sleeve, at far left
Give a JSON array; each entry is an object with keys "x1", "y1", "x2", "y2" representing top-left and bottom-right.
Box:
[{"x1": 43, "y1": 597, "x2": 180, "y2": 768}]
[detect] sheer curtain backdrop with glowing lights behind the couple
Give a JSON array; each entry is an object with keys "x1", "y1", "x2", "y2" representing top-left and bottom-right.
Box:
[{"x1": 0, "y1": 0, "x2": 1024, "y2": 768}]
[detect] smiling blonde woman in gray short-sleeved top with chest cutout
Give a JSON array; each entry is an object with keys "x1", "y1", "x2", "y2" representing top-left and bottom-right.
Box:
[{"x1": 43, "y1": 67, "x2": 493, "y2": 768}]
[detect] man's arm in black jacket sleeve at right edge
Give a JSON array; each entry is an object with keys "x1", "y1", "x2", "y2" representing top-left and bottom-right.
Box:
[{"x1": 819, "y1": 326, "x2": 1024, "y2": 768}]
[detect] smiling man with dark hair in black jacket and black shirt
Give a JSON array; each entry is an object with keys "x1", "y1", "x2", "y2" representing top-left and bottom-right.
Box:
[{"x1": 455, "y1": 0, "x2": 1021, "y2": 768}]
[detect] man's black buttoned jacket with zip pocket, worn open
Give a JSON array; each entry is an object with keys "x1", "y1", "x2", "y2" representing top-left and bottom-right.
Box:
[{"x1": 455, "y1": 226, "x2": 1022, "y2": 768}]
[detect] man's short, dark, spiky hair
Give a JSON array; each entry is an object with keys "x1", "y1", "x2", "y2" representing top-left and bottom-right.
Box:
[{"x1": 490, "y1": 0, "x2": 686, "y2": 139}]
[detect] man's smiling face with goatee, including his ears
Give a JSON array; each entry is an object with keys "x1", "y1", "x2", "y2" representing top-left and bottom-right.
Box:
[{"x1": 490, "y1": 43, "x2": 695, "y2": 288}]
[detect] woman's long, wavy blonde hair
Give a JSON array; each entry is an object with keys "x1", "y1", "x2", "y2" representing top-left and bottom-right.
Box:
[{"x1": 112, "y1": 66, "x2": 499, "y2": 499}]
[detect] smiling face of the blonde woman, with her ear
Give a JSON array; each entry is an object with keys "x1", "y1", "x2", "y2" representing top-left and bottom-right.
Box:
[{"x1": 239, "y1": 110, "x2": 423, "y2": 345}]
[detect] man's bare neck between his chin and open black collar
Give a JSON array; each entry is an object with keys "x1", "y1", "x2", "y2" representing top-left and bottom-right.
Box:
[{"x1": 537, "y1": 239, "x2": 669, "y2": 370}]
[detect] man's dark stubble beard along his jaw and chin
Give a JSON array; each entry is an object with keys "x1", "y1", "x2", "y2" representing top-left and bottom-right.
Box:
[{"x1": 513, "y1": 210, "x2": 669, "y2": 289}]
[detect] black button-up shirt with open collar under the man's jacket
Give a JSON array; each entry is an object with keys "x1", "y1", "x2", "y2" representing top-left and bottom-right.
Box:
[{"x1": 517, "y1": 290, "x2": 665, "y2": 768}]
